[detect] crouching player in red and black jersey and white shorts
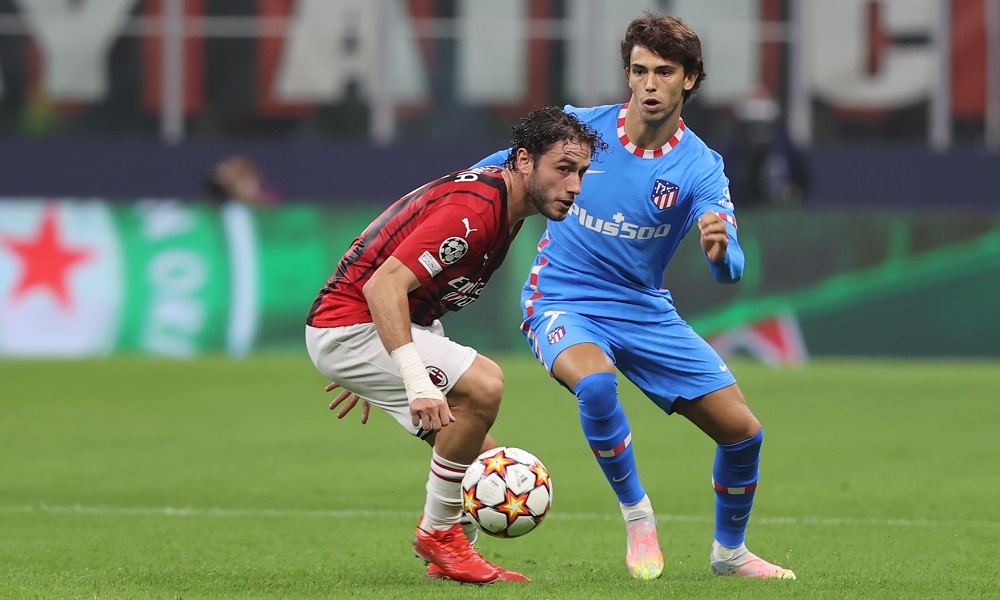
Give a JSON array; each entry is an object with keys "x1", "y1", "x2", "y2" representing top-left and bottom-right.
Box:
[{"x1": 306, "y1": 107, "x2": 607, "y2": 583}]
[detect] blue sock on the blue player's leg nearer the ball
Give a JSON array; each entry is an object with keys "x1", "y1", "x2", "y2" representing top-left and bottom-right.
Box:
[{"x1": 573, "y1": 373, "x2": 646, "y2": 505}]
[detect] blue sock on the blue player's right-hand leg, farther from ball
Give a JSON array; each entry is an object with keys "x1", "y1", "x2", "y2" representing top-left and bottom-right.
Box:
[{"x1": 712, "y1": 429, "x2": 764, "y2": 548}]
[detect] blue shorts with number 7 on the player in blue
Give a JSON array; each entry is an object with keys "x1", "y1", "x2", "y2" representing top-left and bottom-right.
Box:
[{"x1": 521, "y1": 304, "x2": 736, "y2": 414}]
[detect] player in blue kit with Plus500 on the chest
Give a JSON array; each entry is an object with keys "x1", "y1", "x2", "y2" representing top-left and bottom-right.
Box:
[{"x1": 477, "y1": 12, "x2": 795, "y2": 579}]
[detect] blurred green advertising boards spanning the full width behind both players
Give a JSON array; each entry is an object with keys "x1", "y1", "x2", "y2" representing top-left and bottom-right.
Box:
[{"x1": 0, "y1": 198, "x2": 1000, "y2": 363}]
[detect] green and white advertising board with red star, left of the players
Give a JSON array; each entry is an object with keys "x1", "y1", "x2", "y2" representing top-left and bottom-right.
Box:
[{"x1": 0, "y1": 199, "x2": 386, "y2": 358}]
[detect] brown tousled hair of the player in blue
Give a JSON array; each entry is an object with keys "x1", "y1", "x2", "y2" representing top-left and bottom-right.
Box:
[{"x1": 621, "y1": 10, "x2": 706, "y2": 102}]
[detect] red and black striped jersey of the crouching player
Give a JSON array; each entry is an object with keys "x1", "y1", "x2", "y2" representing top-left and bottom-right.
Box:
[{"x1": 306, "y1": 166, "x2": 521, "y2": 327}]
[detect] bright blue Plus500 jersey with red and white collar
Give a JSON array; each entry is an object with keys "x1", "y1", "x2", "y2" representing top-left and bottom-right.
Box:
[{"x1": 477, "y1": 104, "x2": 743, "y2": 321}]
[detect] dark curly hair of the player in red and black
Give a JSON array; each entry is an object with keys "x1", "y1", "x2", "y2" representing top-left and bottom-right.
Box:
[{"x1": 504, "y1": 106, "x2": 608, "y2": 171}]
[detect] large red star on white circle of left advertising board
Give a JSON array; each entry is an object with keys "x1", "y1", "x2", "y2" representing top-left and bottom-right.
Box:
[{"x1": 0, "y1": 206, "x2": 91, "y2": 308}]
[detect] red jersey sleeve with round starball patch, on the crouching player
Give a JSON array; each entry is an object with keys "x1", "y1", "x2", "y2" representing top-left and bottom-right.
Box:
[{"x1": 392, "y1": 202, "x2": 495, "y2": 285}]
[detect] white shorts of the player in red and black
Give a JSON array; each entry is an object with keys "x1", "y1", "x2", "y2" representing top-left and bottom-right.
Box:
[{"x1": 306, "y1": 321, "x2": 478, "y2": 438}]
